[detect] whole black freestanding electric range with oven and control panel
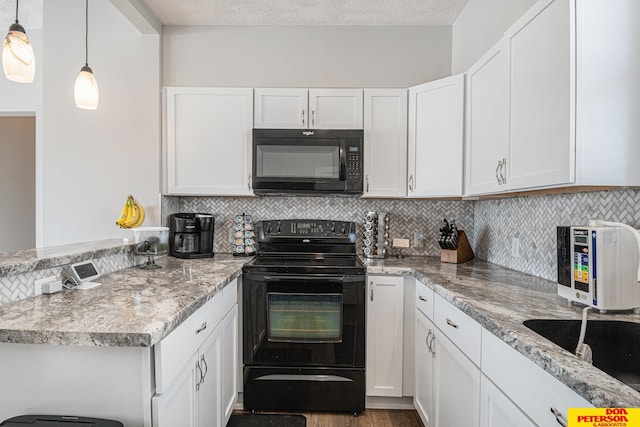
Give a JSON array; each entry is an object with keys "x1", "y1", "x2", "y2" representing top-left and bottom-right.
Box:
[{"x1": 242, "y1": 220, "x2": 366, "y2": 413}]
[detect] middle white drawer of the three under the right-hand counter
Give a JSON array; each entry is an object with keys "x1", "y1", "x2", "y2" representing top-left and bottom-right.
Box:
[{"x1": 434, "y1": 295, "x2": 482, "y2": 366}]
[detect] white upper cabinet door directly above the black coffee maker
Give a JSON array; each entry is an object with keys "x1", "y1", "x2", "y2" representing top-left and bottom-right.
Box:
[{"x1": 165, "y1": 88, "x2": 253, "y2": 195}]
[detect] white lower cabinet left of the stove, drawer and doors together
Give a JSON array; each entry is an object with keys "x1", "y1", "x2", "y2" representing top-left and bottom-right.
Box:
[{"x1": 151, "y1": 281, "x2": 238, "y2": 427}]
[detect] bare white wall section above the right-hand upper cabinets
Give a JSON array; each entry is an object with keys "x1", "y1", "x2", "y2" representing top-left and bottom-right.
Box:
[{"x1": 451, "y1": 0, "x2": 536, "y2": 74}]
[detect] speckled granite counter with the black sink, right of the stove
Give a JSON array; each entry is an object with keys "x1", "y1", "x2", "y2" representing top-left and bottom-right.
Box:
[{"x1": 365, "y1": 257, "x2": 640, "y2": 407}]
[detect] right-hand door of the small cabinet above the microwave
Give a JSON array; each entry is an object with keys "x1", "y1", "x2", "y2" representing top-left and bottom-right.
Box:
[{"x1": 309, "y1": 89, "x2": 363, "y2": 129}]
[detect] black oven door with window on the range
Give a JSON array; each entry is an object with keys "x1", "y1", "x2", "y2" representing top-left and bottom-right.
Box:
[{"x1": 242, "y1": 274, "x2": 365, "y2": 367}]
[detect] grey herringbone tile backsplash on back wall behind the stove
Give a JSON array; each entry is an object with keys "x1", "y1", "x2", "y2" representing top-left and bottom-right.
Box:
[{"x1": 162, "y1": 196, "x2": 473, "y2": 255}]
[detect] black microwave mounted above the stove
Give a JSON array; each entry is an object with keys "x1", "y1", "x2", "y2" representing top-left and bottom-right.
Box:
[{"x1": 251, "y1": 129, "x2": 364, "y2": 196}]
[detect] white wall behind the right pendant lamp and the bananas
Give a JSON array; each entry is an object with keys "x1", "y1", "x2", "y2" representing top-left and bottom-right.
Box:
[{"x1": 40, "y1": 0, "x2": 160, "y2": 246}]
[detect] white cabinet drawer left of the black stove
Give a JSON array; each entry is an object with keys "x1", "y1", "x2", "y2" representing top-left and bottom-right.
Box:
[{"x1": 154, "y1": 292, "x2": 222, "y2": 393}]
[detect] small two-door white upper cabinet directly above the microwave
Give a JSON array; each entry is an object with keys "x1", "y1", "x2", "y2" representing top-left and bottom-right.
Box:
[{"x1": 254, "y1": 88, "x2": 363, "y2": 129}]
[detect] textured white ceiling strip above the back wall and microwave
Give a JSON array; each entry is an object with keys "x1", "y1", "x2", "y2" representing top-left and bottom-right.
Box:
[{"x1": 142, "y1": 0, "x2": 468, "y2": 25}]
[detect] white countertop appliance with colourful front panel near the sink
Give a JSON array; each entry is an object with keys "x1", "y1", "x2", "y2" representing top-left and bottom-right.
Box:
[{"x1": 557, "y1": 225, "x2": 640, "y2": 312}]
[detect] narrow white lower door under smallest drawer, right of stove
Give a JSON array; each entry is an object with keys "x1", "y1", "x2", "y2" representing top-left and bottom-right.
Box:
[{"x1": 413, "y1": 310, "x2": 434, "y2": 427}]
